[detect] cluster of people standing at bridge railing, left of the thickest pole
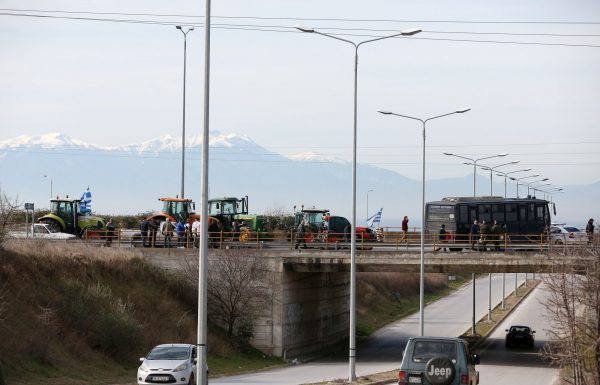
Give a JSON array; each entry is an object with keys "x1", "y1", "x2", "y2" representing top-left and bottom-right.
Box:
[{"x1": 140, "y1": 214, "x2": 200, "y2": 248}]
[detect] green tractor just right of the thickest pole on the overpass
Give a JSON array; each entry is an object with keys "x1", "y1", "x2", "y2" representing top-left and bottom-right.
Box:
[{"x1": 208, "y1": 196, "x2": 264, "y2": 233}]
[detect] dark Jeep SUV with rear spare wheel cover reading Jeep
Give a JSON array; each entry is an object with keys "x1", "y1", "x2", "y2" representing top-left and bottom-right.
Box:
[{"x1": 398, "y1": 337, "x2": 479, "y2": 385}]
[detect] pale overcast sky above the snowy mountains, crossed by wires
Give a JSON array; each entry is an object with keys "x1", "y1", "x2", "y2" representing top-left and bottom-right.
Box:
[{"x1": 0, "y1": 0, "x2": 600, "y2": 186}]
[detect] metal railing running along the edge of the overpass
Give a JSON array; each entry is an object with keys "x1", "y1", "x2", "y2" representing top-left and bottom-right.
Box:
[{"x1": 75, "y1": 228, "x2": 600, "y2": 252}]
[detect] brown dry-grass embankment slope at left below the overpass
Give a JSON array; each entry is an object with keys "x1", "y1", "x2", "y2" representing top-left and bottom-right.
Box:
[{"x1": 0, "y1": 240, "x2": 281, "y2": 385}]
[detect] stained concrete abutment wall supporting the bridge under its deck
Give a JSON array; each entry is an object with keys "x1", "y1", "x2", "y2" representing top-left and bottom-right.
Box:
[{"x1": 251, "y1": 257, "x2": 350, "y2": 359}]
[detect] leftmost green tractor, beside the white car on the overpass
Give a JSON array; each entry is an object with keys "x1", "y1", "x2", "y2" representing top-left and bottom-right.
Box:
[{"x1": 37, "y1": 199, "x2": 106, "y2": 237}]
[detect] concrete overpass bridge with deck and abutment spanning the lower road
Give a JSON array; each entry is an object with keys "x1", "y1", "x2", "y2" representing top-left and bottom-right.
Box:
[{"x1": 142, "y1": 248, "x2": 598, "y2": 357}]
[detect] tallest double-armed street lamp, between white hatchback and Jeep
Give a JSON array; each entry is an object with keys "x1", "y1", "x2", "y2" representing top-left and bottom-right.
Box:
[{"x1": 296, "y1": 26, "x2": 421, "y2": 381}]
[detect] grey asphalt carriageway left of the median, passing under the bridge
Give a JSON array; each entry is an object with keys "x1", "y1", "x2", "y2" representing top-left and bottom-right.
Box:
[{"x1": 210, "y1": 274, "x2": 525, "y2": 385}]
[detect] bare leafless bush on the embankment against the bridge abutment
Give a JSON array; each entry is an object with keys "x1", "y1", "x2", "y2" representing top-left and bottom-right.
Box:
[{"x1": 183, "y1": 249, "x2": 268, "y2": 338}]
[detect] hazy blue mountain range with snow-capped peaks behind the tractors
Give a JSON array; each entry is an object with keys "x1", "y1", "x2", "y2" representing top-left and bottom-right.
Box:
[{"x1": 0, "y1": 132, "x2": 600, "y2": 226}]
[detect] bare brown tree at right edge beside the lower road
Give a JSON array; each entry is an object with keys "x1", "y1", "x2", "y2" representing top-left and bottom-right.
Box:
[{"x1": 543, "y1": 249, "x2": 600, "y2": 385}]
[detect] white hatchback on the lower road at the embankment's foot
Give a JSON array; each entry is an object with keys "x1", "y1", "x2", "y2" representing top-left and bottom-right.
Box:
[{"x1": 137, "y1": 344, "x2": 197, "y2": 385}]
